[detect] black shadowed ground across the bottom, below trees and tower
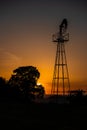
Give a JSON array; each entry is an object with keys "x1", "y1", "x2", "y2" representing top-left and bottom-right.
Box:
[{"x1": 0, "y1": 101, "x2": 87, "y2": 130}]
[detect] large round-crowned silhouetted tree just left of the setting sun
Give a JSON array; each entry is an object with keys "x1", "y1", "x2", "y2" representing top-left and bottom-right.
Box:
[{"x1": 8, "y1": 66, "x2": 40, "y2": 100}]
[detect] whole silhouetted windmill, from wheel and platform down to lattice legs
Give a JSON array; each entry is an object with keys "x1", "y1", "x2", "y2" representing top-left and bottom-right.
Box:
[{"x1": 51, "y1": 19, "x2": 70, "y2": 95}]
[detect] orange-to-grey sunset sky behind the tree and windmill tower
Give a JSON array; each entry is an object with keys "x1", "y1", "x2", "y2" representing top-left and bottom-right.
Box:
[{"x1": 0, "y1": 0, "x2": 87, "y2": 93}]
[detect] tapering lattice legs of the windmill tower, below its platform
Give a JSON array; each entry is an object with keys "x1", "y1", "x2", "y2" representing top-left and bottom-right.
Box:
[{"x1": 51, "y1": 42, "x2": 70, "y2": 95}]
